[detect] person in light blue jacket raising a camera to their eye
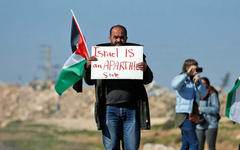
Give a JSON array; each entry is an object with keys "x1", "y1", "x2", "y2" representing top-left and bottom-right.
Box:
[{"x1": 172, "y1": 59, "x2": 207, "y2": 150}]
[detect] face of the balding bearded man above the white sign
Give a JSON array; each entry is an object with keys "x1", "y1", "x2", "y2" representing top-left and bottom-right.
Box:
[{"x1": 109, "y1": 27, "x2": 127, "y2": 46}]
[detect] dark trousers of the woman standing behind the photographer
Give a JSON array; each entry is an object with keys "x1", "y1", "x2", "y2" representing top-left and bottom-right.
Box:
[{"x1": 196, "y1": 128, "x2": 218, "y2": 150}]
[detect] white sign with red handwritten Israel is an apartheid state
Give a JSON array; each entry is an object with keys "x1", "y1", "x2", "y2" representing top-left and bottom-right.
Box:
[{"x1": 91, "y1": 46, "x2": 143, "y2": 79}]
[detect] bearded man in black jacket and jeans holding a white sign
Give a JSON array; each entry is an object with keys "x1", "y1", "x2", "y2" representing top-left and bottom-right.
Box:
[{"x1": 84, "y1": 25, "x2": 153, "y2": 150}]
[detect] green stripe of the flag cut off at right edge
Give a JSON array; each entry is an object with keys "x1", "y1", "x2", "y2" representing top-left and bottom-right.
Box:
[{"x1": 225, "y1": 80, "x2": 240, "y2": 118}]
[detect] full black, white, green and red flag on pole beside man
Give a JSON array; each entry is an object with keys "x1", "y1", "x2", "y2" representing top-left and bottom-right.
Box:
[{"x1": 55, "y1": 10, "x2": 89, "y2": 95}]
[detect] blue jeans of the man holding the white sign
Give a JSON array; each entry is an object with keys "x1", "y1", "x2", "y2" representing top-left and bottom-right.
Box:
[{"x1": 102, "y1": 106, "x2": 140, "y2": 150}]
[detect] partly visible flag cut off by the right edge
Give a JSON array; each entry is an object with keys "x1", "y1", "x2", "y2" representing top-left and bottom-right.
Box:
[{"x1": 225, "y1": 77, "x2": 240, "y2": 123}]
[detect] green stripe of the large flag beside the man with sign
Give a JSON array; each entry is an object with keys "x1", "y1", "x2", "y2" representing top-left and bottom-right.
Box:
[{"x1": 55, "y1": 60, "x2": 87, "y2": 95}]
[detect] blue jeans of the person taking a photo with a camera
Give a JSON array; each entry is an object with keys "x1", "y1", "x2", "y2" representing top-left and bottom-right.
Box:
[{"x1": 180, "y1": 118, "x2": 198, "y2": 150}]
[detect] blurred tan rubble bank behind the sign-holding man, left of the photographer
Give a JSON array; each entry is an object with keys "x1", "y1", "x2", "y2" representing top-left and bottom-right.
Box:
[{"x1": 0, "y1": 81, "x2": 178, "y2": 129}]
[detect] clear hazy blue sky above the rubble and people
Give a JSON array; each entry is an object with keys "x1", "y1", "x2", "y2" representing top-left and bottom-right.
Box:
[{"x1": 0, "y1": 0, "x2": 240, "y2": 91}]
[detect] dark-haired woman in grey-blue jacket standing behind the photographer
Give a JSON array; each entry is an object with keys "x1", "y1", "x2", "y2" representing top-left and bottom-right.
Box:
[{"x1": 196, "y1": 77, "x2": 220, "y2": 150}]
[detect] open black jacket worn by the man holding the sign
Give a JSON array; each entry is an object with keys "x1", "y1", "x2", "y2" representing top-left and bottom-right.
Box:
[{"x1": 84, "y1": 43, "x2": 153, "y2": 130}]
